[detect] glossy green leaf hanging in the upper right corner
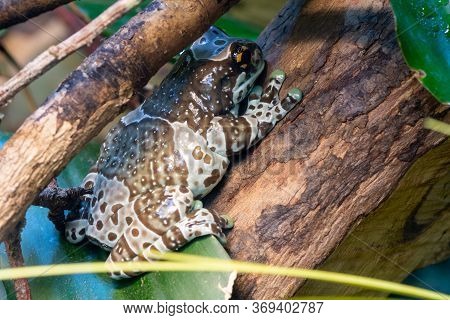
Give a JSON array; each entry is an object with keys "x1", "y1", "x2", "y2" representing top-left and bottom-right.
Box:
[{"x1": 391, "y1": 0, "x2": 450, "y2": 104}]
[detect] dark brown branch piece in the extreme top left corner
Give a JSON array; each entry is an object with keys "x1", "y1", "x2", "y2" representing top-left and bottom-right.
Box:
[{"x1": 0, "y1": 0, "x2": 73, "y2": 29}]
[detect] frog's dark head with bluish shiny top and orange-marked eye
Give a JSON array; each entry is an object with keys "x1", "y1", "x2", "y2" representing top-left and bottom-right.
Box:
[{"x1": 171, "y1": 27, "x2": 265, "y2": 114}]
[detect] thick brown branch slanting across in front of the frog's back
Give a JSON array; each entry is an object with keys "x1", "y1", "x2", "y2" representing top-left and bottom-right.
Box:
[{"x1": 0, "y1": 0, "x2": 237, "y2": 239}]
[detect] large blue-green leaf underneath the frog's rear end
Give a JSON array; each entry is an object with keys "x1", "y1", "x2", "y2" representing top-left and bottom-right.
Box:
[{"x1": 0, "y1": 132, "x2": 233, "y2": 299}]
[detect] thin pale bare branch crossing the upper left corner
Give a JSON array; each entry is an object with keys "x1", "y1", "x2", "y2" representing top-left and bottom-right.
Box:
[{"x1": 0, "y1": 0, "x2": 141, "y2": 109}]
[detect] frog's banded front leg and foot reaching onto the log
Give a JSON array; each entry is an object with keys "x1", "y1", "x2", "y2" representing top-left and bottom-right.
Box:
[{"x1": 207, "y1": 70, "x2": 302, "y2": 155}]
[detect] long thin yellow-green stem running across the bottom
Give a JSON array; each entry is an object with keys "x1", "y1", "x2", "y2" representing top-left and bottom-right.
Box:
[{"x1": 0, "y1": 253, "x2": 450, "y2": 299}]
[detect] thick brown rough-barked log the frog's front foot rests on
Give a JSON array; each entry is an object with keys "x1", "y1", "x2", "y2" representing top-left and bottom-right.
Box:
[{"x1": 206, "y1": 0, "x2": 450, "y2": 299}]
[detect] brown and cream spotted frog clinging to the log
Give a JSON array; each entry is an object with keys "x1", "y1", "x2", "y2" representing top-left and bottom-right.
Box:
[{"x1": 65, "y1": 26, "x2": 302, "y2": 279}]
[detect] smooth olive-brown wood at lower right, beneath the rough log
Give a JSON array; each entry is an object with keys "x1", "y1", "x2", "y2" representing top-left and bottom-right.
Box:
[{"x1": 297, "y1": 139, "x2": 450, "y2": 297}]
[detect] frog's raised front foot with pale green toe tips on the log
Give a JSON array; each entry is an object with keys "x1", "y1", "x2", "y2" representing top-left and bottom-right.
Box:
[{"x1": 245, "y1": 70, "x2": 302, "y2": 140}]
